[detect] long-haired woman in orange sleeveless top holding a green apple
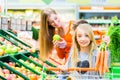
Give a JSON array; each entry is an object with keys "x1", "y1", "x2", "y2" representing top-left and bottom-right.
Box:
[{"x1": 39, "y1": 8, "x2": 72, "y2": 62}]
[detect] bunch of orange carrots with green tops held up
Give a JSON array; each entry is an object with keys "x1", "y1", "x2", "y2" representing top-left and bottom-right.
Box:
[{"x1": 96, "y1": 42, "x2": 109, "y2": 76}]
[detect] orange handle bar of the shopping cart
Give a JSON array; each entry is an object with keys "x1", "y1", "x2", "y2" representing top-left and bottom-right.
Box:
[{"x1": 47, "y1": 68, "x2": 96, "y2": 71}]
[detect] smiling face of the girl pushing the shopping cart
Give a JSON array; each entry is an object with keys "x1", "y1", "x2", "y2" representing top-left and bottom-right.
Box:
[{"x1": 76, "y1": 28, "x2": 90, "y2": 48}]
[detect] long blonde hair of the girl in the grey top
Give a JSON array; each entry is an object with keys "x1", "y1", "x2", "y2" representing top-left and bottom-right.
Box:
[{"x1": 72, "y1": 23, "x2": 96, "y2": 67}]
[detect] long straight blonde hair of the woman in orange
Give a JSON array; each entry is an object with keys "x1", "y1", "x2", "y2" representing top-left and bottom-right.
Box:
[{"x1": 39, "y1": 8, "x2": 56, "y2": 60}]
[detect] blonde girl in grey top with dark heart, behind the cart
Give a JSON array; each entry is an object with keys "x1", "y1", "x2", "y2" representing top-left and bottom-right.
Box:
[{"x1": 62, "y1": 23, "x2": 98, "y2": 79}]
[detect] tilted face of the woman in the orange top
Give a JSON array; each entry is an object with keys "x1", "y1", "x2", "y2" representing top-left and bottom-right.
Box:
[{"x1": 48, "y1": 14, "x2": 61, "y2": 28}]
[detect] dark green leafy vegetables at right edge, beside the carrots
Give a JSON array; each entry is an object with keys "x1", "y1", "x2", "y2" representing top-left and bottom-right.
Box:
[{"x1": 108, "y1": 26, "x2": 120, "y2": 62}]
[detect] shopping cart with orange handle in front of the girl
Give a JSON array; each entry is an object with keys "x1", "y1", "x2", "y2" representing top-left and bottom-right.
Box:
[{"x1": 44, "y1": 68, "x2": 112, "y2": 80}]
